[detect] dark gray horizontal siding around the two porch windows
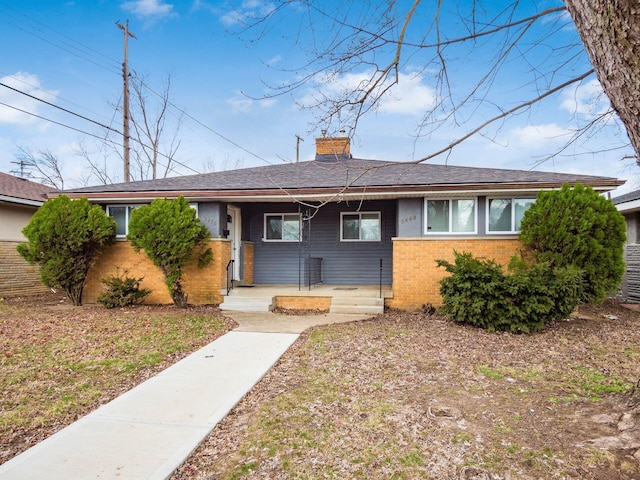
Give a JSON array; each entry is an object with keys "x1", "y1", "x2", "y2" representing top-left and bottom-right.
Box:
[{"x1": 250, "y1": 201, "x2": 396, "y2": 285}]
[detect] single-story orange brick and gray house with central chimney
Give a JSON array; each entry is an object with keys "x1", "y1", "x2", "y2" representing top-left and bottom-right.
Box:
[{"x1": 56, "y1": 137, "x2": 624, "y2": 310}]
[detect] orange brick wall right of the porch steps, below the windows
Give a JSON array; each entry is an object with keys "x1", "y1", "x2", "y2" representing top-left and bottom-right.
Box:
[{"x1": 386, "y1": 238, "x2": 520, "y2": 310}]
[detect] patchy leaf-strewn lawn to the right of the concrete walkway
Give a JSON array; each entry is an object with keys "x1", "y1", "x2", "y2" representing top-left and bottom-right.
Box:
[{"x1": 173, "y1": 302, "x2": 640, "y2": 480}]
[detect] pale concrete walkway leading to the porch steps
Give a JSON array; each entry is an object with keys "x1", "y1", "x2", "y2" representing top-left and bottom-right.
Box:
[{"x1": 0, "y1": 312, "x2": 370, "y2": 480}]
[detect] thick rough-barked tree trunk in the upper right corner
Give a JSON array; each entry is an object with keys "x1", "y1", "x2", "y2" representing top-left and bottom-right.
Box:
[{"x1": 566, "y1": 0, "x2": 640, "y2": 163}]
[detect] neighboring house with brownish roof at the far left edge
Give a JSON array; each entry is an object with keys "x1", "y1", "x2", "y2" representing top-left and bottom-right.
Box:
[{"x1": 0, "y1": 173, "x2": 52, "y2": 297}]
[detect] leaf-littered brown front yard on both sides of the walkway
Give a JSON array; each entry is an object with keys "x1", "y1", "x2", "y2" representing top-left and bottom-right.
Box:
[{"x1": 0, "y1": 290, "x2": 640, "y2": 480}]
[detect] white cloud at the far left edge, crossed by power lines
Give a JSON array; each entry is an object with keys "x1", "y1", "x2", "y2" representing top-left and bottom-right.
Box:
[{"x1": 0, "y1": 72, "x2": 58, "y2": 125}]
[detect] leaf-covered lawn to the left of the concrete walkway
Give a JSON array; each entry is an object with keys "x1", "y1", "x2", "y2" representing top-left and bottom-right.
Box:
[{"x1": 0, "y1": 294, "x2": 231, "y2": 463}]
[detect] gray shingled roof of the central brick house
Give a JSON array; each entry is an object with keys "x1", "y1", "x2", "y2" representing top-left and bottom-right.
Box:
[{"x1": 58, "y1": 158, "x2": 624, "y2": 197}]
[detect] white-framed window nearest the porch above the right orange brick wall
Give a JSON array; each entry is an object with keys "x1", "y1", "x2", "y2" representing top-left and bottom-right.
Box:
[{"x1": 424, "y1": 198, "x2": 478, "y2": 235}]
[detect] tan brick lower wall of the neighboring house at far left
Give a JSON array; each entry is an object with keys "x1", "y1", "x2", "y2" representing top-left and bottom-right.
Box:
[{"x1": 0, "y1": 241, "x2": 49, "y2": 297}]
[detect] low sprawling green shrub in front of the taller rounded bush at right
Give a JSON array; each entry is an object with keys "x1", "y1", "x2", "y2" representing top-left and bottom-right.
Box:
[{"x1": 438, "y1": 252, "x2": 583, "y2": 333}]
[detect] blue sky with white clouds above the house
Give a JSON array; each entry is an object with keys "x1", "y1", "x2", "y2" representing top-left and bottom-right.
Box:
[{"x1": 0, "y1": 0, "x2": 640, "y2": 193}]
